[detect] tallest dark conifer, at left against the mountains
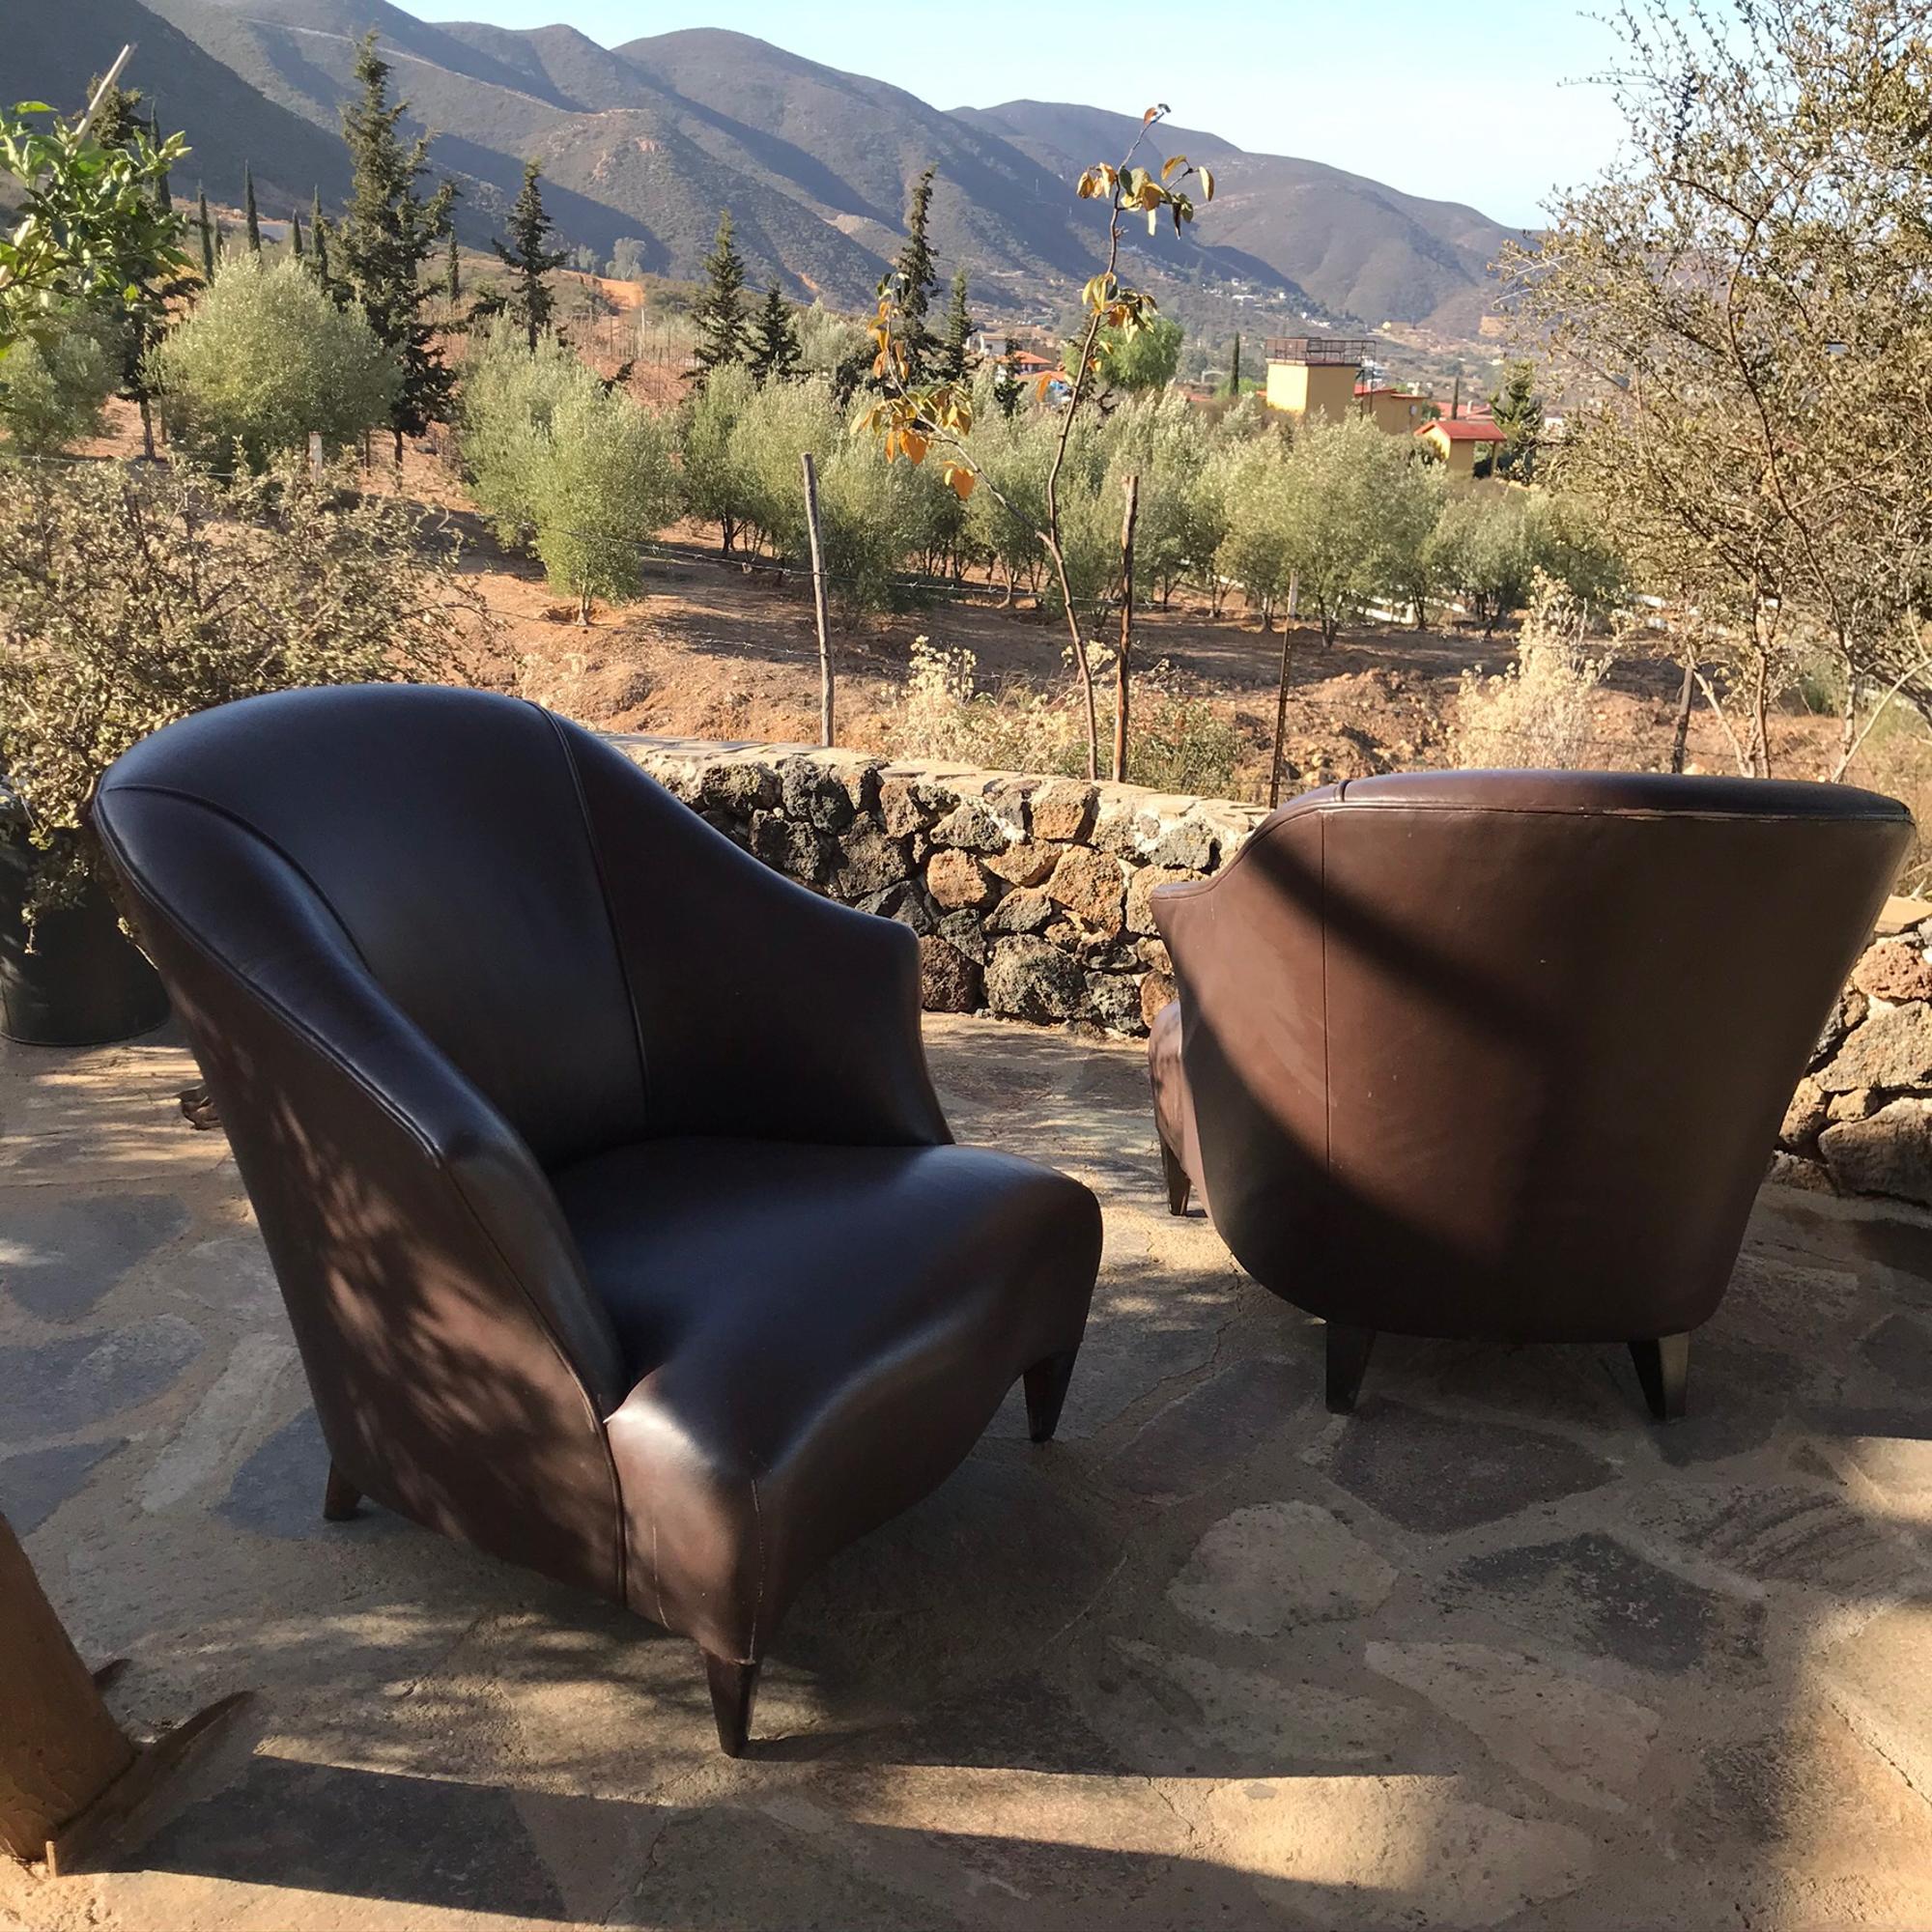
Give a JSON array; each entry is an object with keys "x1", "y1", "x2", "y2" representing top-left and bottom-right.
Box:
[{"x1": 336, "y1": 31, "x2": 456, "y2": 464}]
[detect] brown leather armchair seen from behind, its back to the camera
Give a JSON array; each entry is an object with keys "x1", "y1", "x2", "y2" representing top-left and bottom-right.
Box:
[{"x1": 1150, "y1": 771, "x2": 1913, "y2": 1420}]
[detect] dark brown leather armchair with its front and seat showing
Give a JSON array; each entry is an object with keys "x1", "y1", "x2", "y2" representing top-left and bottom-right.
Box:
[{"x1": 95, "y1": 686, "x2": 1099, "y2": 1754}]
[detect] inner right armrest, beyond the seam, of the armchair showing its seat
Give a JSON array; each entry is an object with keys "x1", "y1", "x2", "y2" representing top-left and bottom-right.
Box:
[{"x1": 558, "y1": 724, "x2": 952, "y2": 1146}]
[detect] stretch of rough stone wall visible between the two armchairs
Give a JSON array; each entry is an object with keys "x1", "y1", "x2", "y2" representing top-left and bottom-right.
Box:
[{"x1": 612, "y1": 734, "x2": 1265, "y2": 1034}]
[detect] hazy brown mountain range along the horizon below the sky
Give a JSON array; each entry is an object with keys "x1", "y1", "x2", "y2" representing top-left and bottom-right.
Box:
[{"x1": 22, "y1": 0, "x2": 1511, "y2": 336}]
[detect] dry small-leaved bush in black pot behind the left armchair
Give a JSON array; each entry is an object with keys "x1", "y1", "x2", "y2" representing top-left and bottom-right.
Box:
[{"x1": 0, "y1": 462, "x2": 479, "y2": 1045}]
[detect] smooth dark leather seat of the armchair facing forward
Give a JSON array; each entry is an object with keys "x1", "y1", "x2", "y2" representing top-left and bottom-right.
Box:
[{"x1": 551, "y1": 1136, "x2": 1099, "y2": 1658}]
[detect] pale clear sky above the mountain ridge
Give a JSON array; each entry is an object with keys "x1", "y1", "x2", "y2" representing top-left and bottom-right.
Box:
[{"x1": 400, "y1": 0, "x2": 1615, "y2": 224}]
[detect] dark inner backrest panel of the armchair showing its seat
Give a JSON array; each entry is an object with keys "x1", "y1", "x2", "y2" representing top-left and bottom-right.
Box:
[{"x1": 104, "y1": 686, "x2": 645, "y2": 1167}]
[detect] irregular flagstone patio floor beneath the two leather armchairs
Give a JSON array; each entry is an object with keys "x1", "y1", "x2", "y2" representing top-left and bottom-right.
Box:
[{"x1": 0, "y1": 1020, "x2": 1932, "y2": 1932}]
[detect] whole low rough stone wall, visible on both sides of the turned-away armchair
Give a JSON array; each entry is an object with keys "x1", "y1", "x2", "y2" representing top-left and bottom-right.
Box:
[{"x1": 612, "y1": 734, "x2": 1932, "y2": 1208}]
